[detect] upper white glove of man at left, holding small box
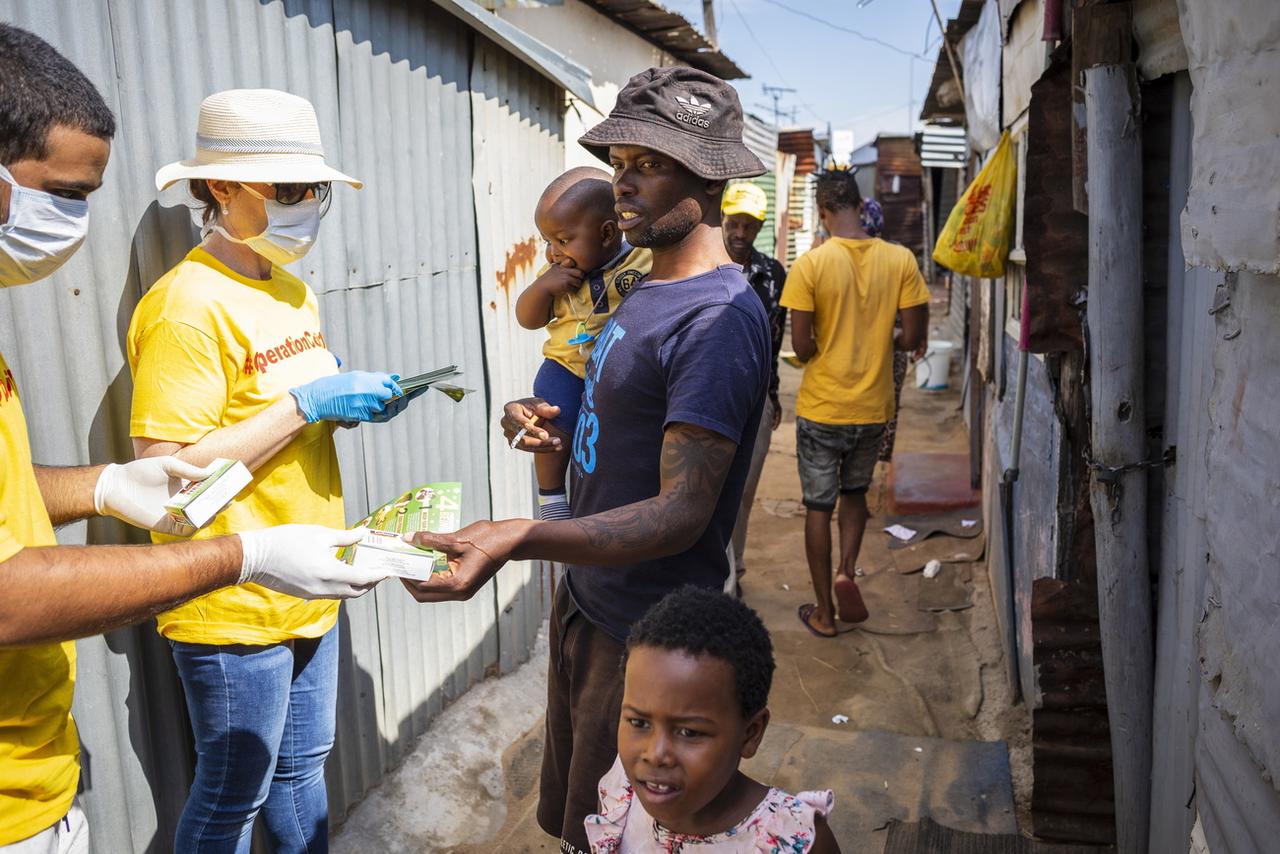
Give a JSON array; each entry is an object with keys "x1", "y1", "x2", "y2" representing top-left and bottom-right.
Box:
[{"x1": 93, "y1": 457, "x2": 214, "y2": 536}]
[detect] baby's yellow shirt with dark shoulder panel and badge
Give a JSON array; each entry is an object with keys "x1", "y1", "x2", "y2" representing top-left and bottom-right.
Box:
[{"x1": 538, "y1": 247, "x2": 653, "y2": 379}]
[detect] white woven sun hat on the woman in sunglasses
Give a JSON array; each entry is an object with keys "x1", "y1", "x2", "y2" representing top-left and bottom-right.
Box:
[{"x1": 156, "y1": 88, "x2": 364, "y2": 189}]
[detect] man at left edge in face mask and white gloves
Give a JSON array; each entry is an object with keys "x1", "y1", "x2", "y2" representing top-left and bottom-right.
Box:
[{"x1": 0, "y1": 24, "x2": 383, "y2": 854}]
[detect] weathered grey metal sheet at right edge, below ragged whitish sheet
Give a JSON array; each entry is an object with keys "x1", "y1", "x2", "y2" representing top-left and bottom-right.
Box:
[{"x1": 1178, "y1": 263, "x2": 1280, "y2": 851}]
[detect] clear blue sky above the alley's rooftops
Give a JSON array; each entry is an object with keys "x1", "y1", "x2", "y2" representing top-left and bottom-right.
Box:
[{"x1": 658, "y1": 0, "x2": 960, "y2": 151}]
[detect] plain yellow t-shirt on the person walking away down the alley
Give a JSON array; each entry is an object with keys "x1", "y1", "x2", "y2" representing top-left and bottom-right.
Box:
[{"x1": 782, "y1": 237, "x2": 929, "y2": 424}]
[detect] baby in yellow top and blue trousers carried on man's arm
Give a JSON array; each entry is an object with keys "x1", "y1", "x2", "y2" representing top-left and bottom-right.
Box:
[{"x1": 516, "y1": 166, "x2": 653, "y2": 520}]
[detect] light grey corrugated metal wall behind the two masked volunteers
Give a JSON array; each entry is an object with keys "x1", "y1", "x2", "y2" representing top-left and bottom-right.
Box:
[{"x1": 0, "y1": 0, "x2": 563, "y2": 853}]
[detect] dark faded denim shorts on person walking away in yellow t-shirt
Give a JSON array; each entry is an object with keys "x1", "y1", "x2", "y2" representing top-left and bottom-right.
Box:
[{"x1": 796, "y1": 417, "x2": 884, "y2": 513}]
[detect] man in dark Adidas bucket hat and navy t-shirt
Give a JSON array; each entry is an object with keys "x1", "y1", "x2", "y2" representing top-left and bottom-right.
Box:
[{"x1": 406, "y1": 68, "x2": 771, "y2": 851}]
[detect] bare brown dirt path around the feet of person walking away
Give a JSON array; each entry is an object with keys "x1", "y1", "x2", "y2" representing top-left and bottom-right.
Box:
[{"x1": 742, "y1": 330, "x2": 1030, "y2": 827}]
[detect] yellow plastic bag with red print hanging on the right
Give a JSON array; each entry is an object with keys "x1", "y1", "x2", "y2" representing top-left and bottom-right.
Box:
[{"x1": 933, "y1": 131, "x2": 1018, "y2": 279}]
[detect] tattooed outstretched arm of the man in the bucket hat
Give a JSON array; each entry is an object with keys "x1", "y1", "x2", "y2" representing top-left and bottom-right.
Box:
[{"x1": 404, "y1": 424, "x2": 737, "y2": 602}]
